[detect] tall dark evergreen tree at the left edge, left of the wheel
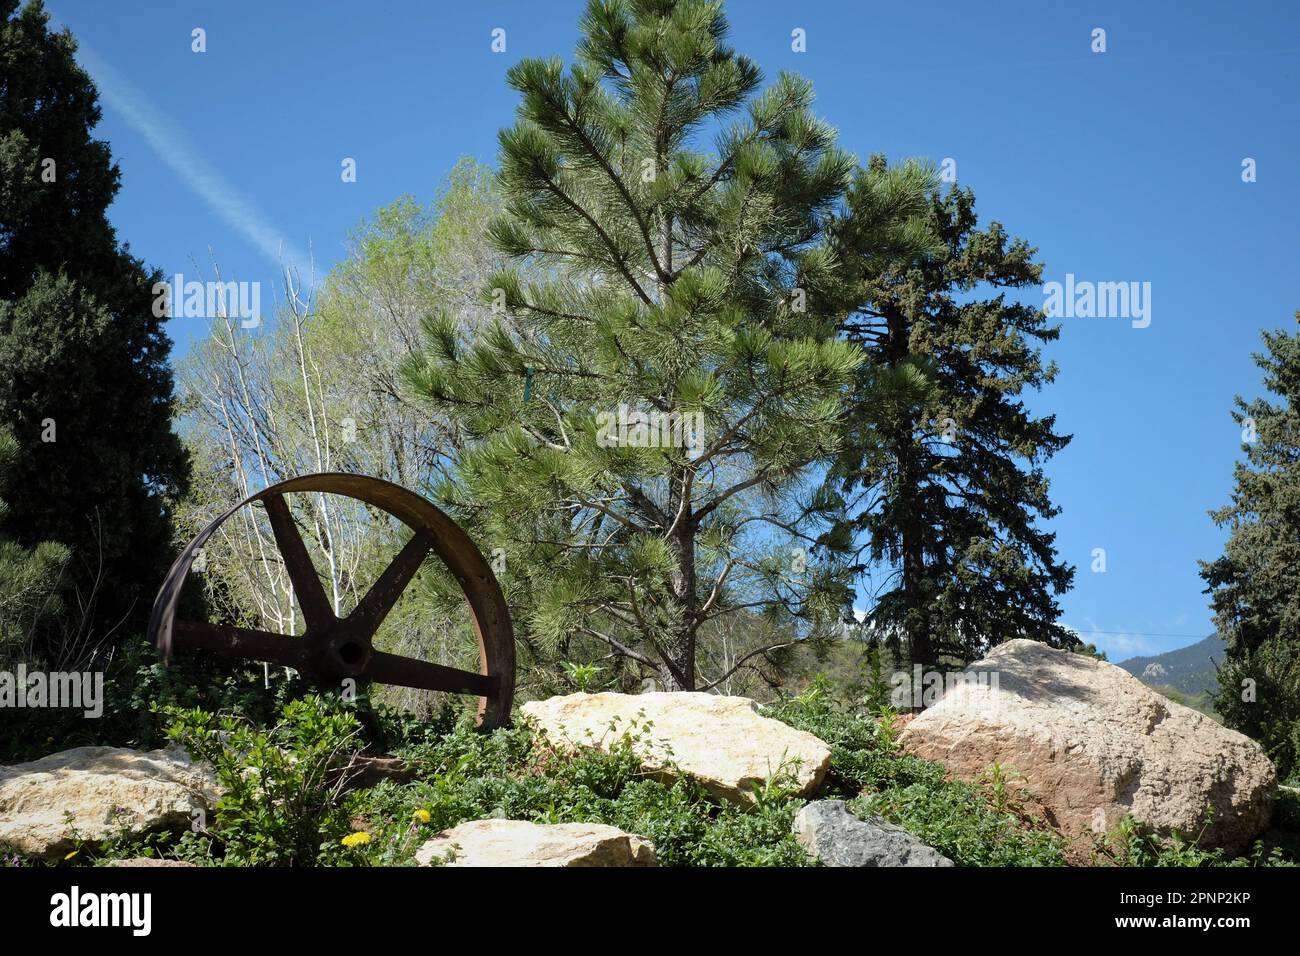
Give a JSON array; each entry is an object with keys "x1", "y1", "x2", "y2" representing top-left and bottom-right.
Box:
[{"x1": 0, "y1": 0, "x2": 186, "y2": 656}]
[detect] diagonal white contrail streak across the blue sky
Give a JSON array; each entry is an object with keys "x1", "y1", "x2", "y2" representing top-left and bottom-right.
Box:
[{"x1": 69, "y1": 34, "x2": 311, "y2": 281}]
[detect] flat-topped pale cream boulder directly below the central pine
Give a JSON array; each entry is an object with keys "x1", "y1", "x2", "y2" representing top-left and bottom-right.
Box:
[{"x1": 521, "y1": 693, "x2": 831, "y2": 803}]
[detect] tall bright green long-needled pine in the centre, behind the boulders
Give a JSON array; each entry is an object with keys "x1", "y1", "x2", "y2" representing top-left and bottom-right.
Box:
[{"x1": 408, "y1": 0, "x2": 859, "y2": 689}]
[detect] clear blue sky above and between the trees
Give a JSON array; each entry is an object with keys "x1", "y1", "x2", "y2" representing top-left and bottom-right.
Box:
[{"x1": 47, "y1": 0, "x2": 1300, "y2": 659}]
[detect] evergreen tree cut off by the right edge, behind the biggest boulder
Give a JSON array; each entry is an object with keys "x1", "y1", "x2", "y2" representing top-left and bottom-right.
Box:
[{"x1": 1201, "y1": 321, "x2": 1300, "y2": 778}]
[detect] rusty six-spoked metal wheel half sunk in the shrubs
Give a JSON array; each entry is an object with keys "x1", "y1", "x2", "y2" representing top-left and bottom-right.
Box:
[{"x1": 150, "y1": 473, "x2": 515, "y2": 730}]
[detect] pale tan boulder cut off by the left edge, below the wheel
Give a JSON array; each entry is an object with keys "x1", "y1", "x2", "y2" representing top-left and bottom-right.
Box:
[{"x1": 0, "y1": 747, "x2": 217, "y2": 860}]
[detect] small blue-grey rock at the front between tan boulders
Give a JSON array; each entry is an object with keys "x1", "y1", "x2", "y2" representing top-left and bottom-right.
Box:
[{"x1": 794, "y1": 800, "x2": 953, "y2": 866}]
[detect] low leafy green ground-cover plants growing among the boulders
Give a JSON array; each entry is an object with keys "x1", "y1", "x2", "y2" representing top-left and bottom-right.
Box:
[{"x1": 48, "y1": 682, "x2": 1300, "y2": 866}]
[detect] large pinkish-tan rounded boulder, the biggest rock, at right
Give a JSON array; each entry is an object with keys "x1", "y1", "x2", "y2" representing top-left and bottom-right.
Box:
[{"x1": 898, "y1": 640, "x2": 1277, "y2": 851}]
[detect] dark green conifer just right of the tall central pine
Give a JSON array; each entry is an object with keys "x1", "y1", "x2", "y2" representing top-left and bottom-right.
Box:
[{"x1": 827, "y1": 164, "x2": 1076, "y2": 665}]
